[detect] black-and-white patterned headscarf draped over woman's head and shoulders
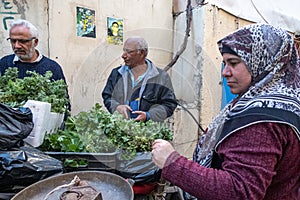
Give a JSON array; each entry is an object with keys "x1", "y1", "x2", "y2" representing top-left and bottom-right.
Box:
[{"x1": 194, "y1": 24, "x2": 300, "y2": 167}]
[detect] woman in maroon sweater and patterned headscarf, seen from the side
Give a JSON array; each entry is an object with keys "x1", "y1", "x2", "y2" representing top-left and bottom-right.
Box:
[{"x1": 152, "y1": 24, "x2": 300, "y2": 200}]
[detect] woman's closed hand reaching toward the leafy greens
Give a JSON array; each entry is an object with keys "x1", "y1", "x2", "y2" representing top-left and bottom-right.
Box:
[{"x1": 151, "y1": 139, "x2": 175, "y2": 169}]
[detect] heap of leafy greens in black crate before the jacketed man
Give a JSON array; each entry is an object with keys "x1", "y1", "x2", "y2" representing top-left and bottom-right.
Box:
[{"x1": 41, "y1": 103, "x2": 172, "y2": 157}]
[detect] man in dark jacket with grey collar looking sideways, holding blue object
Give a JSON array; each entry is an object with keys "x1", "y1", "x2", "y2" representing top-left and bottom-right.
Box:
[{"x1": 102, "y1": 37, "x2": 177, "y2": 121}]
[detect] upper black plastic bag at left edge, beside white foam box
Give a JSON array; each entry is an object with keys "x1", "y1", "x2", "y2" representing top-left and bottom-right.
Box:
[{"x1": 0, "y1": 103, "x2": 33, "y2": 150}]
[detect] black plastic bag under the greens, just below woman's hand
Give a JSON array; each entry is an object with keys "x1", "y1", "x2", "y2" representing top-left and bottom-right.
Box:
[{"x1": 116, "y1": 152, "x2": 161, "y2": 184}]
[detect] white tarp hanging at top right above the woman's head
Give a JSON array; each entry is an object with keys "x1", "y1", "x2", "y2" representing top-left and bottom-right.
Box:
[{"x1": 207, "y1": 0, "x2": 300, "y2": 32}]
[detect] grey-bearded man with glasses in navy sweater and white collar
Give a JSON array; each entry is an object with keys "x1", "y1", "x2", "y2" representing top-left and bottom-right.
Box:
[{"x1": 0, "y1": 19, "x2": 65, "y2": 81}]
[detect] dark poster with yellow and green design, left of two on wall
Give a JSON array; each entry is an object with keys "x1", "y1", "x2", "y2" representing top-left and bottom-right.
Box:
[{"x1": 76, "y1": 6, "x2": 96, "y2": 38}]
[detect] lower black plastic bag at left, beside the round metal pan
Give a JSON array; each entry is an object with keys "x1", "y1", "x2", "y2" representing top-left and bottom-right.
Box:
[{"x1": 0, "y1": 145, "x2": 63, "y2": 193}]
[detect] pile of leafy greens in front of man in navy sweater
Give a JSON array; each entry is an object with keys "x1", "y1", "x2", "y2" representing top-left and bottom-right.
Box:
[{"x1": 0, "y1": 68, "x2": 69, "y2": 113}]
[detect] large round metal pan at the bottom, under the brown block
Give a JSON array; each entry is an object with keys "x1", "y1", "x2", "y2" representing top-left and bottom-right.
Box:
[{"x1": 11, "y1": 171, "x2": 134, "y2": 200}]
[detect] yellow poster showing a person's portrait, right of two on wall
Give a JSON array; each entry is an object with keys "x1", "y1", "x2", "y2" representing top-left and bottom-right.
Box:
[{"x1": 107, "y1": 17, "x2": 123, "y2": 45}]
